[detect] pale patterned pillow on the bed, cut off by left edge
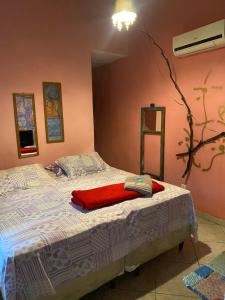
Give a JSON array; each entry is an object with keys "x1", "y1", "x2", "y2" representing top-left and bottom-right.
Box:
[{"x1": 0, "y1": 164, "x2": 55, "y2": 191}]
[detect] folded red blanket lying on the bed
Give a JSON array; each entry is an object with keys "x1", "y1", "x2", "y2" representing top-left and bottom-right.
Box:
[{"x1": 71, "y1": 180, "x2": 164, "y2": 209}]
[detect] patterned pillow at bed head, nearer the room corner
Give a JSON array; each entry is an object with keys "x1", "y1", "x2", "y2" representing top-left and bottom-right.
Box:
[{"x1": 56, "y1": 152, "x2": 107, "y2": 177}]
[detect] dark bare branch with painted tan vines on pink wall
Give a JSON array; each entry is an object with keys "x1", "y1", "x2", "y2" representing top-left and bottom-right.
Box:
[{"x1": 137, "y1": 30, "x2": 225, "y2": 182}]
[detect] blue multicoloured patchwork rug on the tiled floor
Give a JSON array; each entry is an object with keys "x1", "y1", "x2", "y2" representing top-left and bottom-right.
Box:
[{"x1": 183, "y1": 252, "x2": 225, "y2": 300}]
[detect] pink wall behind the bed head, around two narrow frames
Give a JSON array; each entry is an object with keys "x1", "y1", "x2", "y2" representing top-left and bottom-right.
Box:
[{"x1": 0, "y1": 0, "x2": 127, "y2": 169}]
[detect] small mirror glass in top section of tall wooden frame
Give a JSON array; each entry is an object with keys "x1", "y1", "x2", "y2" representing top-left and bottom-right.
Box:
[{"x1": 145, "y1": 109, "x2": 162, "y2": 132}]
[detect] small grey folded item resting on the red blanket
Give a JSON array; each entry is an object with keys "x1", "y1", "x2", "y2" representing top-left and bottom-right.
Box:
[{"x1": 124, "y1": 175, "x2": 152, "y2": 197}]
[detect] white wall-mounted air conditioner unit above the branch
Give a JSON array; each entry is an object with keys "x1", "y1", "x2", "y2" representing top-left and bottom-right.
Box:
[{"x1": 173, "y1": 20, "x2": 225, "y2": 56}]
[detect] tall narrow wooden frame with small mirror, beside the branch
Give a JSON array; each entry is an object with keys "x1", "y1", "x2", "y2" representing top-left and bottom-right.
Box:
[{"x1": 140, "y1": 104, "x2": 166, "y2": 180}]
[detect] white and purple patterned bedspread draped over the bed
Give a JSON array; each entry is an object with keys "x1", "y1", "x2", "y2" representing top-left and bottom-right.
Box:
[{"x1": 0, "y1": 168, "x2": 196, "y2": 300}]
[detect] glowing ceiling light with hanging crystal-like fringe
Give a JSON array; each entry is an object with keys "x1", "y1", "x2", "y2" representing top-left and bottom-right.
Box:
[{"x1": 112, "y1": 0, "x2": 137, "y2": 31}]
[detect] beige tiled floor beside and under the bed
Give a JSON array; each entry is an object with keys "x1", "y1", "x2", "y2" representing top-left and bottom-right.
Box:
[{"x1": 82, "y1": 218, "x2": 225, "y2": 300}]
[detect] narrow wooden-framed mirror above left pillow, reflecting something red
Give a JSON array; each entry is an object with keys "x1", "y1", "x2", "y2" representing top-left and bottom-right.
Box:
[{"x1": 13, "y1": 93, "x2": 39, "y2": 158}]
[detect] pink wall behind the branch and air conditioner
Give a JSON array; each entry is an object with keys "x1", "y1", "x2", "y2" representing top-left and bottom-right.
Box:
[{"x1": 94, "y1": 0, "x2": 225, "y2": 219}]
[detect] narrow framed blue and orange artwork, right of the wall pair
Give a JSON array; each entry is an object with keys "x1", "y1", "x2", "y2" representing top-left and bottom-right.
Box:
[{"x1": 43, "y1": 82, "x2": 64, "y2": 143}]
